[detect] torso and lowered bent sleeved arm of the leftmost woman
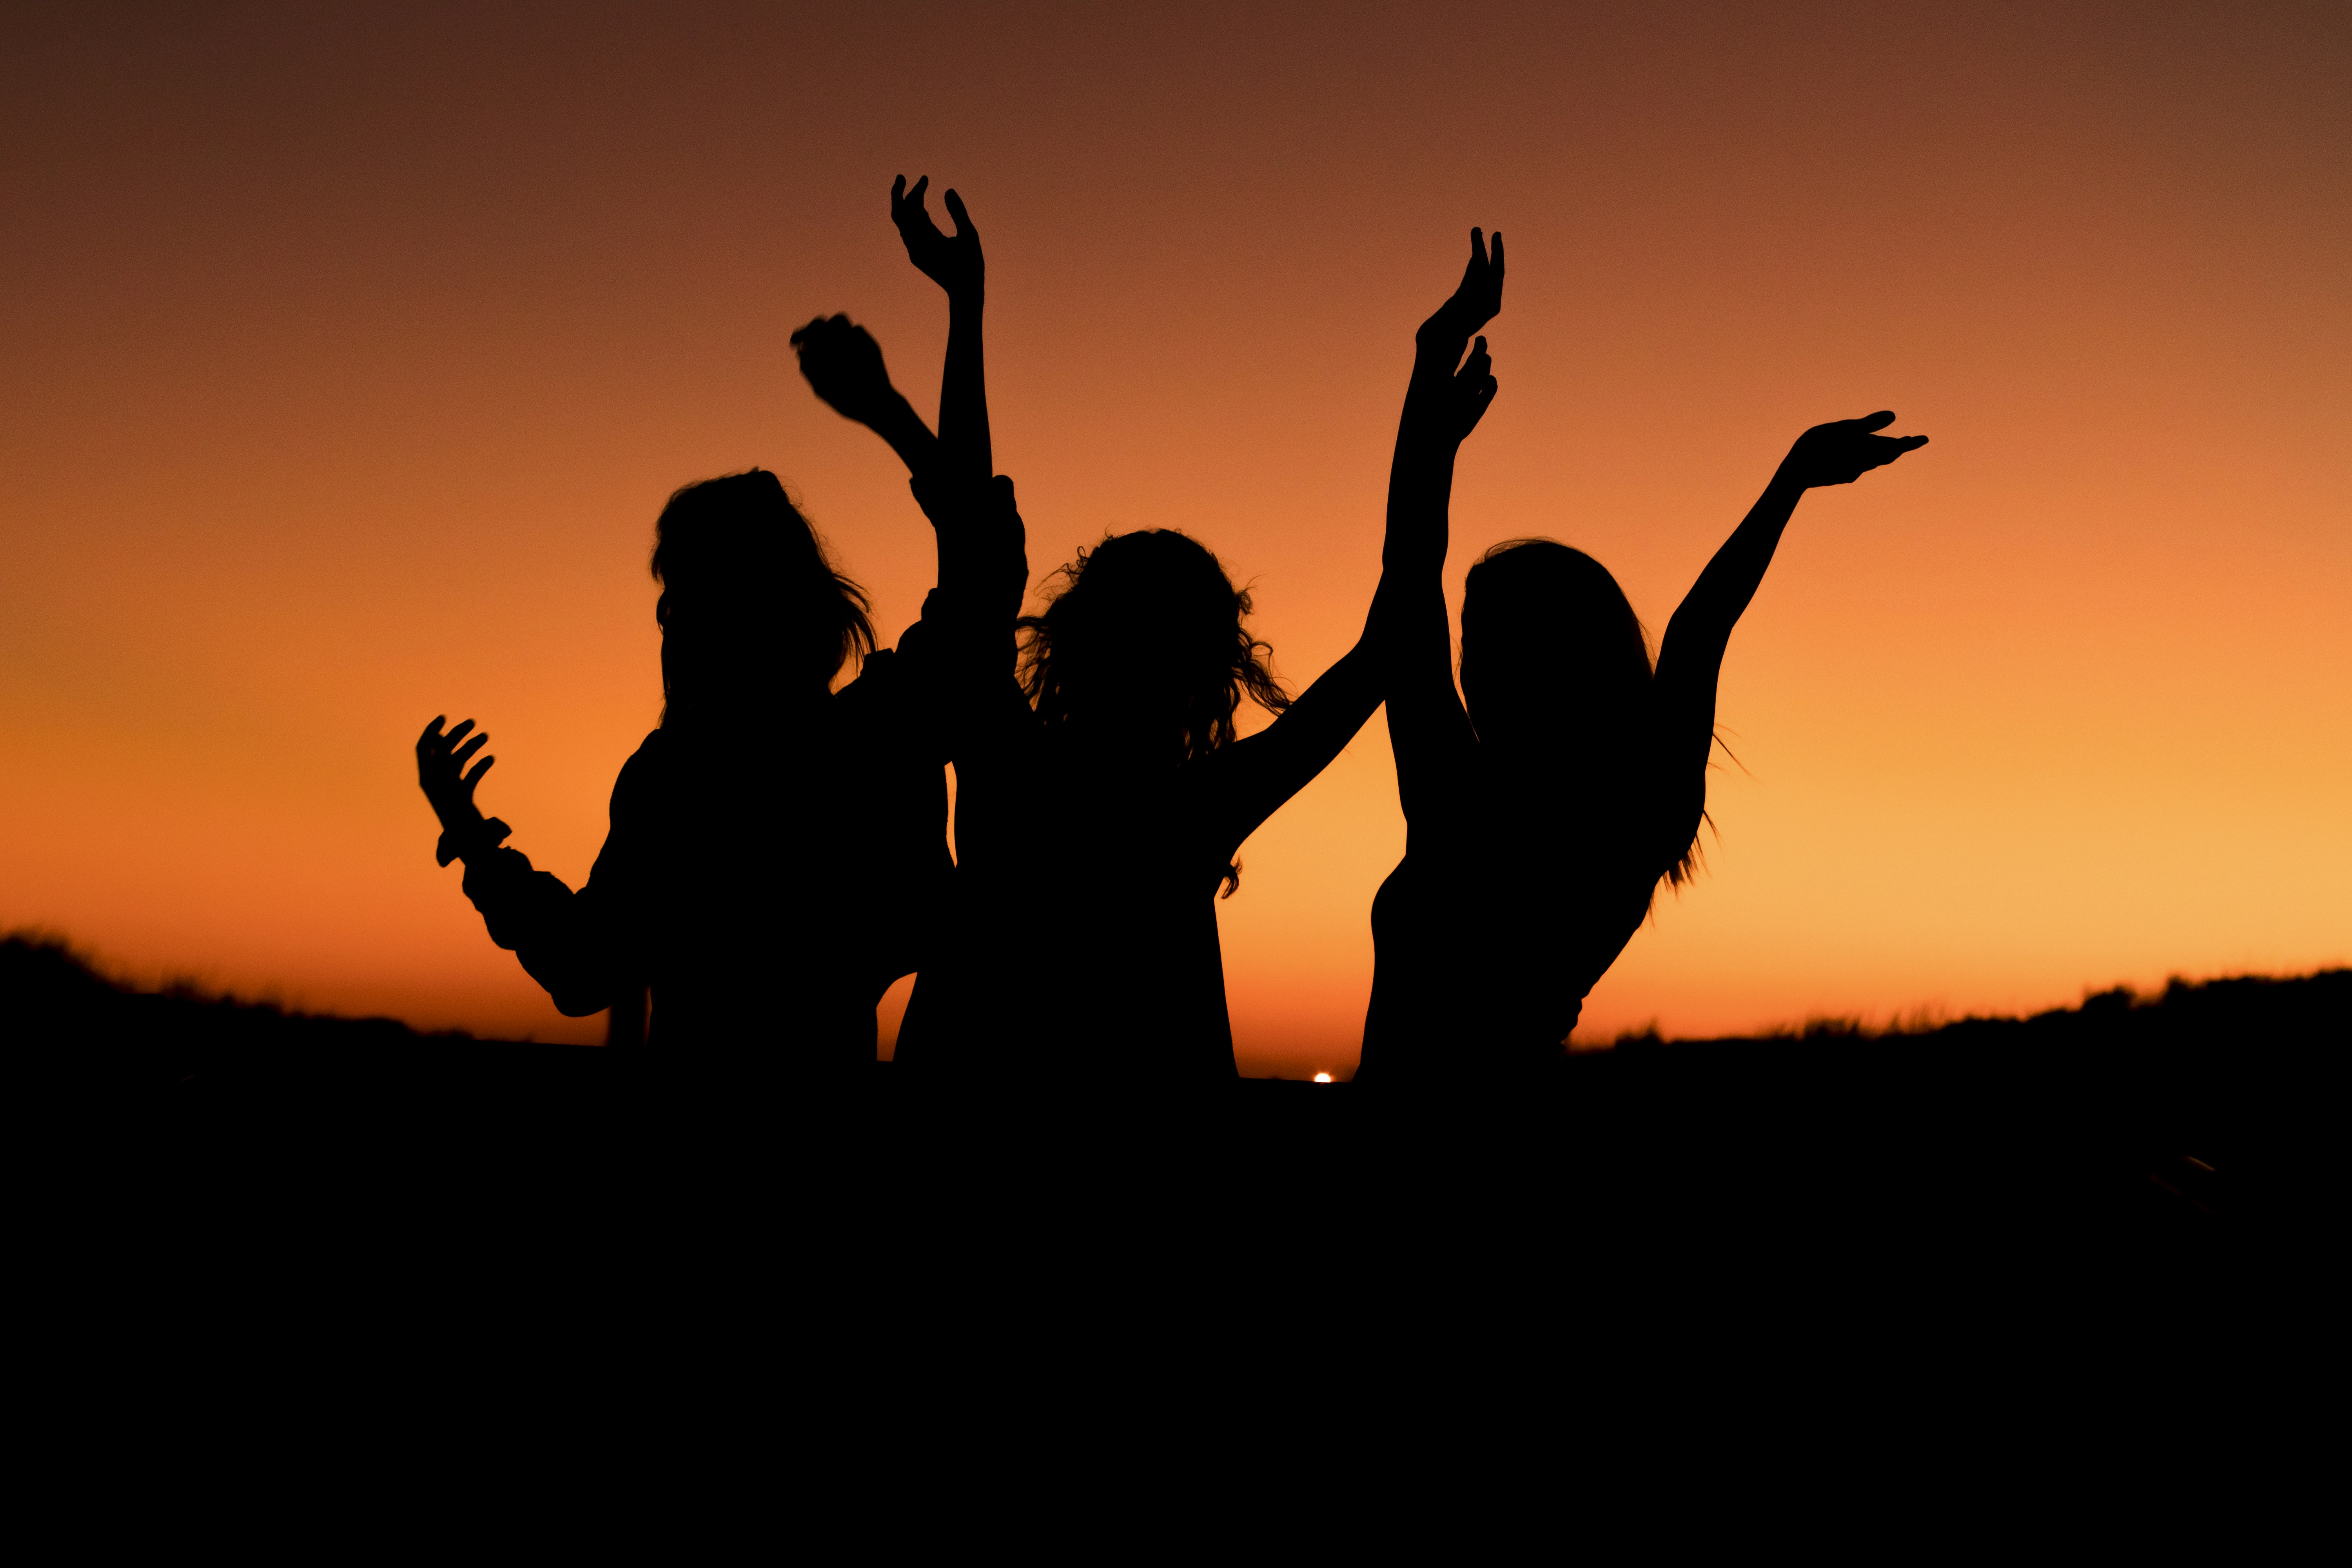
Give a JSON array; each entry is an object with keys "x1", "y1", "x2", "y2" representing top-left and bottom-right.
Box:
[{"x1": 466, "y1": 635, "x2": 948, "y2": 1074}]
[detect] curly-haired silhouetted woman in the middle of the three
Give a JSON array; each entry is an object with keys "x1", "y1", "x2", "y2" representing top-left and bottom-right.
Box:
[{"x1": 811, "y1": 175, "x2": 1484, "y2": 1086}]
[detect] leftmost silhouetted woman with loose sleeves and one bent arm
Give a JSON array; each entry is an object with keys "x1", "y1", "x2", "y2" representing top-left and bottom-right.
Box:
[{"x1": 416, "y1": 470, "x2": 948, "y2": 1077}]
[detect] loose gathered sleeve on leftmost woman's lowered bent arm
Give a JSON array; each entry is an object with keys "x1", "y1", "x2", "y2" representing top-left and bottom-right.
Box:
[{"x1": 466, "y1": 731, "x2": 661, "y2": 1018}]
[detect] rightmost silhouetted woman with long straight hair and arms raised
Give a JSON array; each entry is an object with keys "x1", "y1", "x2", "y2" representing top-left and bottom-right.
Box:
[{"x1": 1357, "y1": 278, "x2": 1926, "y2": 1084}]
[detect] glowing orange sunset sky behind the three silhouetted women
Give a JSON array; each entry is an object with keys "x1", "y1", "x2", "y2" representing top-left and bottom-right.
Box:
[{"x1": 0, "y1": 5, "x2": 2352, "y2": 1072}]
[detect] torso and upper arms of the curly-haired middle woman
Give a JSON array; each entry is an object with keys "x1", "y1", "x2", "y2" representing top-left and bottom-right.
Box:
[{"x1": 898, "y1": 479, "x2": 1381, "y2": 1089}]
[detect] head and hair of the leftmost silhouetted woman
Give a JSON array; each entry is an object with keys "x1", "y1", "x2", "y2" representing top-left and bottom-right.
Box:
[{"x1": 654, "y1": 468, "x2": 875, "y2": 724}]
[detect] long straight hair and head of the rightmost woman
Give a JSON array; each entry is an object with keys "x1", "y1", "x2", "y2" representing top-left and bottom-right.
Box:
[{"x1": 1463, "y1": 538, "x2": 1712, "y2": 889}]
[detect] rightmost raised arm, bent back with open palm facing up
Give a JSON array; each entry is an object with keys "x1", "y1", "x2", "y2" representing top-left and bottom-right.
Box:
[{"x1": 1656, "y1": 411, "x2": 1926, "y2": 769}]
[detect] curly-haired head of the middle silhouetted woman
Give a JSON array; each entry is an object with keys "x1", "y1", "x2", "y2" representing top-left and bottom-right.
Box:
[{"x1": 1018, "y1": 529, "x2": 1291, "y2": 896}]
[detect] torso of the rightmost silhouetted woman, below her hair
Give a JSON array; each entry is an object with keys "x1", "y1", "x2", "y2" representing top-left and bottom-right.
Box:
[{"x1": 1357, "y1": 740, "x2": 1705, "y2": 1082}]
